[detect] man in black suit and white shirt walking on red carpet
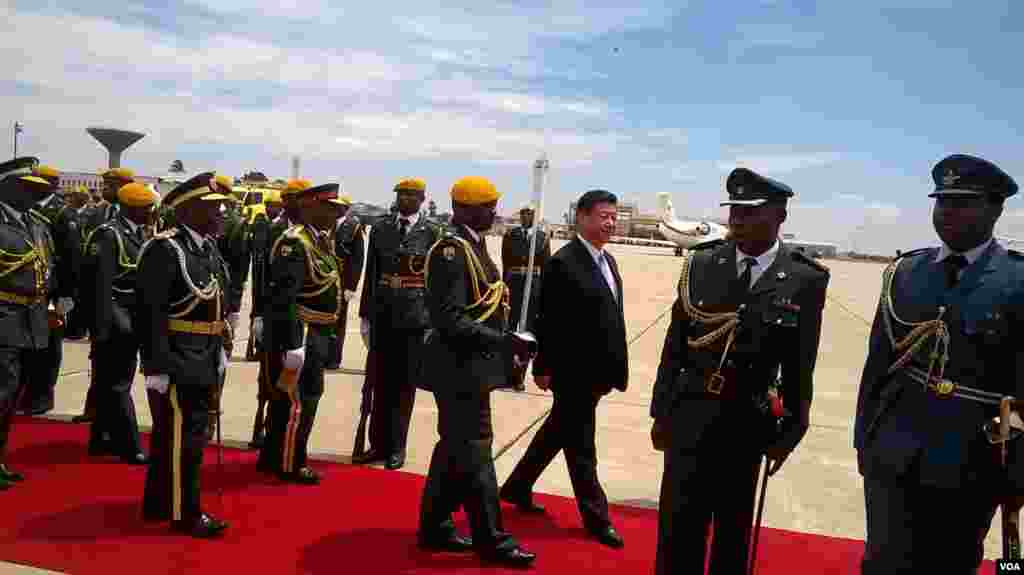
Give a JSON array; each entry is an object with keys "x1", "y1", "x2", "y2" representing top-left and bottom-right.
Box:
[{"x1": 502, "y1": 189, "x2": 629, "y2": 547}]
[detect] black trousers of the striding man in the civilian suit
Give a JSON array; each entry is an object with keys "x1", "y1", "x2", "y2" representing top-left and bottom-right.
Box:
[{"x1": 502, "y1": 391, "x2": 611, "y2": 532}]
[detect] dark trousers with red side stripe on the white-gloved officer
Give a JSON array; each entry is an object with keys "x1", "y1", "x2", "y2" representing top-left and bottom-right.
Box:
[{"x1": 259, "y1": 328, "x2": 330, "y2": 474}]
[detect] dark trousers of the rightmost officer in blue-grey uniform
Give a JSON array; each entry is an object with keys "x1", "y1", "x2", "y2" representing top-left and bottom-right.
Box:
[{"x1": 861, "y1": 479, "x2": 996, "y2": 575}]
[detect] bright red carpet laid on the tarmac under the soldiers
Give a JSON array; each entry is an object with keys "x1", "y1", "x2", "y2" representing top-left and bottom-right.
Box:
[{"x1": 0, "y1": 417, "x2": 992, "y2": 575}]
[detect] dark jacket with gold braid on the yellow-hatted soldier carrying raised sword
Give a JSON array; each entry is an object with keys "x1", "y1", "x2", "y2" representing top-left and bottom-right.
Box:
[{"x1": 424, "y1": 225, "x2": 509, "y2": 392}]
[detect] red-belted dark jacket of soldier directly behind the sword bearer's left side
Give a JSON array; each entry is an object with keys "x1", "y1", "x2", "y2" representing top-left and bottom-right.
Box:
[{"x1": 359, "y1": 214, "x2": 440, "y2": 337}]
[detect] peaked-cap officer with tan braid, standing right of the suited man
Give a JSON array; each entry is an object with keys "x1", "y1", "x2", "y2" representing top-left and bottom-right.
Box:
[{"x1": 650, "y1": 168, "x2": 829, "y2": 575}]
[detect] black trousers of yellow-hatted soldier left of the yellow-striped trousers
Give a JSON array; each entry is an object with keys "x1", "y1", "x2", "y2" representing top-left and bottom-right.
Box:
[{"x1": 89, "y1": 330, "x2": 142, "y2": 455}]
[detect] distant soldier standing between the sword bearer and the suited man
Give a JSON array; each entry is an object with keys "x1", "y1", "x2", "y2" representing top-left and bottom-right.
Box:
[{"x1": 502, "y1": 205, "x2": 551, "y2": 391}]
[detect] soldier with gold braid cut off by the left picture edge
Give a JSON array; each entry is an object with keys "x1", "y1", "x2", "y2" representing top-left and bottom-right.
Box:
[{"x1": 0, "y1": 158, "x2": 56, "y2": 490}]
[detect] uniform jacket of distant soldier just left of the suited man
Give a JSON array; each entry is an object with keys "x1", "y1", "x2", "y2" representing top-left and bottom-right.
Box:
[{"x1": 502, "y1": 226, "x2": 551, "y2": 329}]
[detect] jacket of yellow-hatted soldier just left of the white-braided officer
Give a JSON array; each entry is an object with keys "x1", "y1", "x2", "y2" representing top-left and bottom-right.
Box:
[{"x1": 83, "y1": 216, "x2": 145, "y2": 342}]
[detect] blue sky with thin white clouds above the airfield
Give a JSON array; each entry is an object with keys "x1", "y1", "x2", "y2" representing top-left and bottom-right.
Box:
[{"x1": 6, "y1": 0, "x2": 1024, "y2": 254}]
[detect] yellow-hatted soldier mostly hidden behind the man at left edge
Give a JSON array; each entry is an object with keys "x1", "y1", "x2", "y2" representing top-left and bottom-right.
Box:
[{"x1": 22, "y1": 166, "x2": 80, "y2": 415}]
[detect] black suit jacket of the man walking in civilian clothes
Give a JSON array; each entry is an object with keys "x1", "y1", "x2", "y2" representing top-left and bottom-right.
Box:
[{"x1": 534, "y1": 237, "x2": 629, "y2": 394}]
